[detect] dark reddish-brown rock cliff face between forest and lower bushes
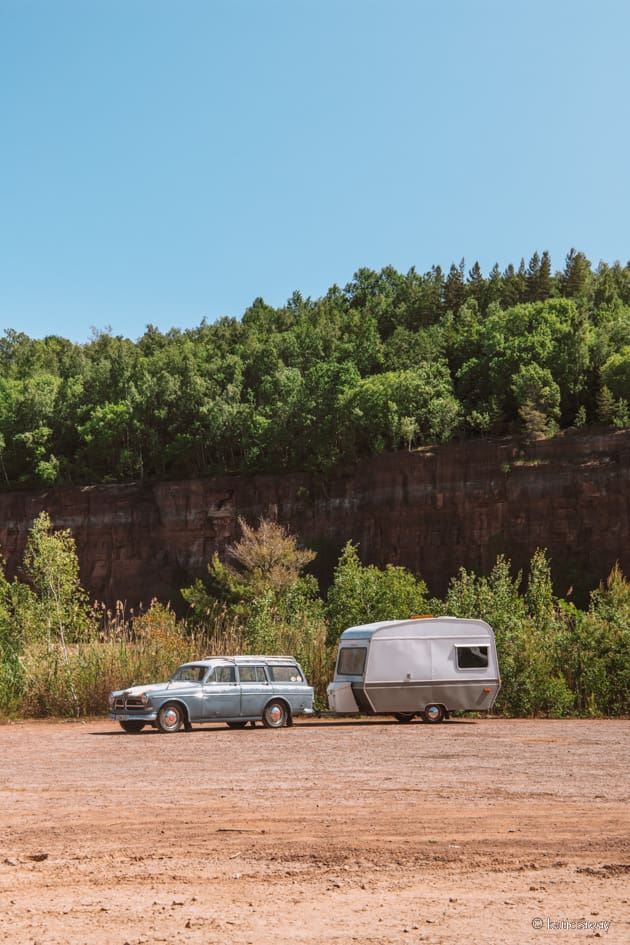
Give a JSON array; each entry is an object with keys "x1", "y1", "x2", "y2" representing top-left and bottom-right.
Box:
[{"x1": 0, "y1": 430, "x2": 630, "y2": 606}]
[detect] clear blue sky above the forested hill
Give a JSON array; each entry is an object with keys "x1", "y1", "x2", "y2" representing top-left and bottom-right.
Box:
[{"x1": 0, "y1": 0, "x2": 630, "y2": 342}]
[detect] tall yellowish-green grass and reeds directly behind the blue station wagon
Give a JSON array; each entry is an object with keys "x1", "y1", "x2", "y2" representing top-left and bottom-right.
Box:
[{"x1": 6, "y1": 601, "x2": 332, "y2": 718}]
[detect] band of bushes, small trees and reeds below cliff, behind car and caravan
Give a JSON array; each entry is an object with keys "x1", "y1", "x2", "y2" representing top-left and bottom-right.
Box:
[{"x1": 0, "y1": 513, "x2": 630, "y2": 717}]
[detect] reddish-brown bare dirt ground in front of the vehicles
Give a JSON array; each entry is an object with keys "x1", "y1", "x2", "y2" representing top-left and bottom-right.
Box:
[{"x1": 0, "y1": 719, "x2": 630, "y2": 945}]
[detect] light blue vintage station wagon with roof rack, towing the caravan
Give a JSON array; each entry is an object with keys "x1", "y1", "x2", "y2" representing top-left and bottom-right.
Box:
[{"x1": 109, "y1": 656, "x2": 314, "y2": 732}]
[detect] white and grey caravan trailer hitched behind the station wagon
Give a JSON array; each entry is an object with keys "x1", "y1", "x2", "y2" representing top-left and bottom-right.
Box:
[{"x1": 327, "y1": 617, "x2": 501, "y2": 722}]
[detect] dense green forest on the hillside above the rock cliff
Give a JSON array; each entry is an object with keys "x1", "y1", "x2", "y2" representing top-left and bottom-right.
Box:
[{"x1": 0, "y1": 249, "x2": 630, "y2": 491}]
